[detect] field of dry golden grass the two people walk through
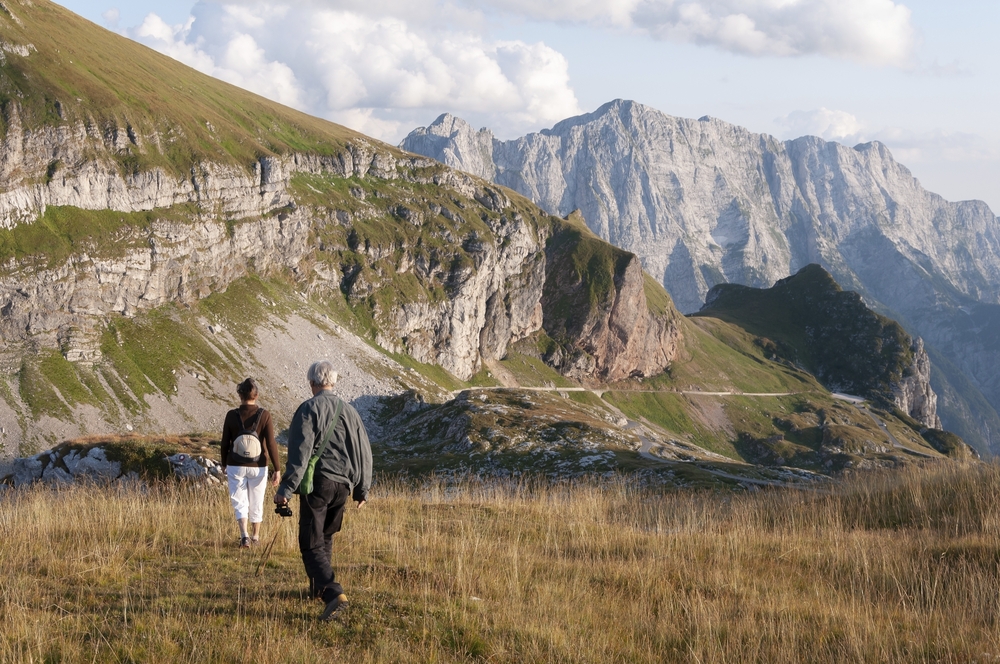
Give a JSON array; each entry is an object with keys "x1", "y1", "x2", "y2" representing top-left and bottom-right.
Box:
[{"x1": 0, "y1": 463, "x2": 1000, "y2": 662}]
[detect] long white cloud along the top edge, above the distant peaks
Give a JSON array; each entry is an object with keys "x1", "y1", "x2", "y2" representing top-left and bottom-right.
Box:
[{"x1": 465, "y1": 0, "x2": 915, "y2": 66}]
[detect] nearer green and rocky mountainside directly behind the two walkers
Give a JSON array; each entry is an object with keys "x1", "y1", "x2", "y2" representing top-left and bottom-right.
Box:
[{"x1": 0, "y1": 0, "x2": 966, "y2": 485}]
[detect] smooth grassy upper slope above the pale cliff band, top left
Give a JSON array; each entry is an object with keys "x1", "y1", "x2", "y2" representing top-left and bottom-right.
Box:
[{"x1": 0, "y1": 0, "x2": 361, "y2": 176}]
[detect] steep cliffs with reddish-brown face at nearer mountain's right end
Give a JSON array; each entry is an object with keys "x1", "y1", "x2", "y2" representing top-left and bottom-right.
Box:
[{"x1": 332, "y1": 174, "x2": 680, "y2": 380}]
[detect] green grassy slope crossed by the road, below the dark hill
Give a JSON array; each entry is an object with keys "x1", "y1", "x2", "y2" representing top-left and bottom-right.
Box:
[{"x1": 605, "y1": 316, "x2": 937, "y2": 464}]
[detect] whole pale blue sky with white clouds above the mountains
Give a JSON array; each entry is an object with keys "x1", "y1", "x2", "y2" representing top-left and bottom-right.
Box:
[{"x1": 52, "y1": 0, "x2": 1000, "y2": 212}]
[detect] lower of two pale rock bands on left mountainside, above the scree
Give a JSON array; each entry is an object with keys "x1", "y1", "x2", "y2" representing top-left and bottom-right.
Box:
[{"x1": 0, "y1": 211, "x2": 312, "y2": 344}]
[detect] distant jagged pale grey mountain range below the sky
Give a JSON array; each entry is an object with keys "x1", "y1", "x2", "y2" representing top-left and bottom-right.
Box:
[{"x1": 401, "y1": 100, "x2": 1000, "y2": 448}]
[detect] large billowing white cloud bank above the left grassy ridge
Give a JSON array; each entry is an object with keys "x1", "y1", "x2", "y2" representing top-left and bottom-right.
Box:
[{"x1": 130, "y1": 0, "x2": 580, "y2": 141}]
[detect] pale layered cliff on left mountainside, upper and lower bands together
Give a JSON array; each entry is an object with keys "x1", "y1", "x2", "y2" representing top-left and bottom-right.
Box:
[{"x1": 0, "y1": 118, "x2": 414, "y2": 361}]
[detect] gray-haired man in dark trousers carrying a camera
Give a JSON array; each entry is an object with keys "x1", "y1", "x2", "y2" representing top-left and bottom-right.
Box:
[{"x1": 274, "y1": 360, "x2": 372, "y2": 620}]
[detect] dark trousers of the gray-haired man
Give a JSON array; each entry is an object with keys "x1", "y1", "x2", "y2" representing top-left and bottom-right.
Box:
[{"x1": 299, "y1": 473, "x2": 351, "y2": 602}]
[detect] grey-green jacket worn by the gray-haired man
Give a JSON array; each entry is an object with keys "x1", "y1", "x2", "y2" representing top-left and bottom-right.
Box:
[{"x1": 278, "y1": 390, "x2": 372, "y2": 501}]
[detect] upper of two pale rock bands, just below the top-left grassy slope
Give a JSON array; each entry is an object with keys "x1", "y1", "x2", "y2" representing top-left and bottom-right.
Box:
[{"x1": 0, "y1": 103, "x2": 397, "y2": 228}]
